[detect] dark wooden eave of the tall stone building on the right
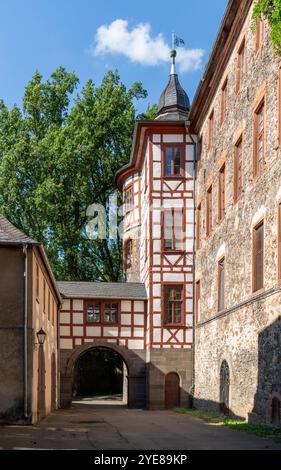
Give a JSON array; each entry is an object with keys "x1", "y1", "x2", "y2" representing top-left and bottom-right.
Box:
[{"x1": 189, "y1": 0, "x2": 253, "y2": 132}]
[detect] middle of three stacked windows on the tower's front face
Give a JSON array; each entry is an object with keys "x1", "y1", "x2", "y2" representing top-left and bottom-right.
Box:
[{"x1": 164, "y1": 209, "x2": 183, "y2": 251}]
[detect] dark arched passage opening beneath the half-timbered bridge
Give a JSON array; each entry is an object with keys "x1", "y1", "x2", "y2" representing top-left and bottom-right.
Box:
[{"x1": 73, "y1": 348, "x2": 127, "y2": 404}]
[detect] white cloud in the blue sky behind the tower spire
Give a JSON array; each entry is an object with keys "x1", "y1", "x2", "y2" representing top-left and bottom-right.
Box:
[{"x1": 90, "y1": 19, "x2": 204, "y2": 72}]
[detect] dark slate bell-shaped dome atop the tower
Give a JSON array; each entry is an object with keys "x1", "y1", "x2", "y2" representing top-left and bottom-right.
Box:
[{"x1": 158, "y1": 74, "x2": 190, "y2": 115}]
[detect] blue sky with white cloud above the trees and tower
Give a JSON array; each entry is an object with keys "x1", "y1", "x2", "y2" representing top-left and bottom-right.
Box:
[{"x1": 0, "y1": 0, "x2": 228, "y2": 112}]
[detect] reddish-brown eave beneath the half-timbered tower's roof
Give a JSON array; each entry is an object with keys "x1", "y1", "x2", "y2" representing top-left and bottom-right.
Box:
[{"x1": 115, "y1": 120, "x2": 188, "y2": 190}]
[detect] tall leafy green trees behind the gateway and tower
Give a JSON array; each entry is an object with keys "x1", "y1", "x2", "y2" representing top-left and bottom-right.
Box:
[{"x1": 0, "y1": 67, "x2": 151, "y2": 281}]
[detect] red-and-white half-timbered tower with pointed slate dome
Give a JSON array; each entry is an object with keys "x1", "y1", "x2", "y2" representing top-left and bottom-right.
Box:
[{"x1": 117, "y1": 51, "x2": 196, "y2": 409}]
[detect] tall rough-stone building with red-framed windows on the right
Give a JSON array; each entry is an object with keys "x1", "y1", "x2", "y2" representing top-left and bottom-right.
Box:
[{"x1": 189, "y1": 0, "x2": 281, "y2": 423}]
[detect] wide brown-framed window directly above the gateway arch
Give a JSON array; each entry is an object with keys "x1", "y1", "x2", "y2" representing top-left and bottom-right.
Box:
[{"x1": 85, "y1": 300, "x2": 119, "y2": 324}]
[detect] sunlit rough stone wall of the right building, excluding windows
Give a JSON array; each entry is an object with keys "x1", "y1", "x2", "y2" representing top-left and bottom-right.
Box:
[{"x1": 195, "y1": 1, "x2": 281, "y2": 421}]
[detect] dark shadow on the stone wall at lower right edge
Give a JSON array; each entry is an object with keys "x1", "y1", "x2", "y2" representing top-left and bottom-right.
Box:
[{"x1": 249, "y1": 317, "x2": 281, "y2": 426}]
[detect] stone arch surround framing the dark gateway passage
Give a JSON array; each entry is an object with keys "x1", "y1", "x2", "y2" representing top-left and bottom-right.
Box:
[{"x1": 61, "y1": 339, "x2": 146, "y2": 408}]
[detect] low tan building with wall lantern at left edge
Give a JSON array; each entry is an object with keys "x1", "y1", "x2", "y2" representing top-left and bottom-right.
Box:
[{"x1": 0, "y1": 216, "x2": 60, "y2": 424}]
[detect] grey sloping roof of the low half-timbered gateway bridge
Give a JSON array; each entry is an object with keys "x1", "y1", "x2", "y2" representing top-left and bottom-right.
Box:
[{"x1": 57, "y1": 281, "x2": 147, "y2": 300}]
